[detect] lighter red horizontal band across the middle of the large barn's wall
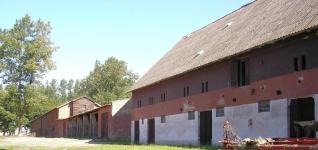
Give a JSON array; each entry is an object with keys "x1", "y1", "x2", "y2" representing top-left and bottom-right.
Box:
[{"x1": 132, "y1": 68, "x2": 318, "y2": 120}]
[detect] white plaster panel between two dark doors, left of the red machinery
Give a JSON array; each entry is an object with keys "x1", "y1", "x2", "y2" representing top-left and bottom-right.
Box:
[{"x1": 155, "y1": 112, "x2": 198, "y2": 145}]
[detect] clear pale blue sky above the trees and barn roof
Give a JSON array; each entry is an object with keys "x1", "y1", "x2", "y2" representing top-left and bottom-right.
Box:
[{"x1": 0, "y1": 0, "x2": 252, "y2": 80}]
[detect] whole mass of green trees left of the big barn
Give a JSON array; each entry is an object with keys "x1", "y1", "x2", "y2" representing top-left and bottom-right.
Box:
[{"x1": 0, "y1": 15, "x2": 138, "y2": 133}]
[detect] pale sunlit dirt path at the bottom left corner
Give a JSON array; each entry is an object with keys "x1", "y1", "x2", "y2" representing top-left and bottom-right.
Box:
[{"x1": 0, "y1": 137, "x2": 97, "y2": 147}]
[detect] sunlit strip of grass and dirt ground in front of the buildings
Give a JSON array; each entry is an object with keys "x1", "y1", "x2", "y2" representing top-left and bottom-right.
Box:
[{"x1": 0, "y1": 137, "x2": 217, "y2": 150}]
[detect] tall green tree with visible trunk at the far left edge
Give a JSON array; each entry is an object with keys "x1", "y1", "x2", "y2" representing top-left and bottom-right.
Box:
[{"x1": 0, "y1": 15, "x2": 56, "y2": 132}]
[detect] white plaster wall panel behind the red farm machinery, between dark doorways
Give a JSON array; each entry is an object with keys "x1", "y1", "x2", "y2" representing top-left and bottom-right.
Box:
[{"x1": 212, "y1": 99, "x2": 288, "y2": 145}]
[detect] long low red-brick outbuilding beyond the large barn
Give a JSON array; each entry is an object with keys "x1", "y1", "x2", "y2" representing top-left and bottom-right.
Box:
[{"x1": 31, "y1": 96, "x2": 131, "y2": 138}]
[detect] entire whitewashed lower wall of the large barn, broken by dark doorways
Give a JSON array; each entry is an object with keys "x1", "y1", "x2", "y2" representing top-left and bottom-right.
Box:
[{"x1": 131, "y1": 95, "x2": 318, "y2": 145}]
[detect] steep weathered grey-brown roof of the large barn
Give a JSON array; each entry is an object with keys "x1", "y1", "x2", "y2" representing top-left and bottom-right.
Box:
[{"x1": 131, "y1": 0, "x2": 318, "y2": 90}]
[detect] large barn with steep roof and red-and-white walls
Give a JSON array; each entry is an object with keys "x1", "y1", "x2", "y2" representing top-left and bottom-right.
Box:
[{"x1": 131, "y1": 0, "x2": 318, "y2": 144}]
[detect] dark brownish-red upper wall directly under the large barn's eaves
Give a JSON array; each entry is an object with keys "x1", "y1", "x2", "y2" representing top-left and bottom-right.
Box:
[{"x1": 132, "y1": 35, "x2": 318, "y2": 107}]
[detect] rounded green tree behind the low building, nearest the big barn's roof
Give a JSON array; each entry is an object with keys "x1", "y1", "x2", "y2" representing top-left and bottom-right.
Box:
[{"x1": 81, "y1": 57, "x2": 138, "y2": 104}]
